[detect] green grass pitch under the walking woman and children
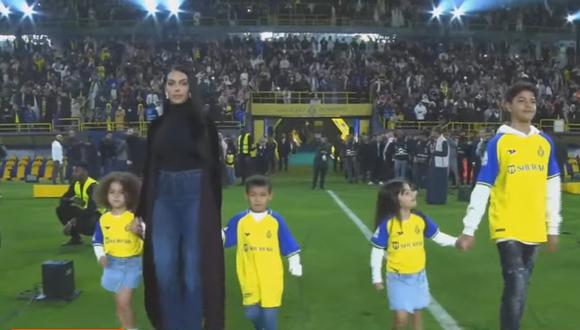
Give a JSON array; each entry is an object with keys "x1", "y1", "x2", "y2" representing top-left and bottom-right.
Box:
[{"x1": 0, "y1": 167, "x2": 580, "y2": 330}]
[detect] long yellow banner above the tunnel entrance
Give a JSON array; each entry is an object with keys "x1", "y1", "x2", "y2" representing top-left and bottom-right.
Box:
[{"x1": 252, "y1": 103, "x2": 372, "y2": 118}]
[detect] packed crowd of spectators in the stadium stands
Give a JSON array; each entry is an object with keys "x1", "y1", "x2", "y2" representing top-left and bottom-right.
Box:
[{"x1": 0, "y1": 35, "x2": 580, "y2": 129}]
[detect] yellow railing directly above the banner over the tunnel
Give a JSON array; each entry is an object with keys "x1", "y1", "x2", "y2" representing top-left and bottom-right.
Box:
[{"x1": 251, "y1": 91, "x2": 370, "y2": 104}]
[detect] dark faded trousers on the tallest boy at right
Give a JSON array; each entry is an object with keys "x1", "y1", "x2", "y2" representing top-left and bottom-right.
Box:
[{"x1": 497, "y1": 241, "x2": 538, "y2": 330}]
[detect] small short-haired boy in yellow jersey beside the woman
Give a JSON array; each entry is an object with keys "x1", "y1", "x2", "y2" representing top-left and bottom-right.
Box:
[{"x1": 223, "y1": 175, "x2": 302, "y2": 330}]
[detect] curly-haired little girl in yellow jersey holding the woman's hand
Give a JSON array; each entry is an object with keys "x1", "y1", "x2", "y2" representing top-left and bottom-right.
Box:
[{"x1": 93, "y1": 172, "x2": 143, "y2": 330}]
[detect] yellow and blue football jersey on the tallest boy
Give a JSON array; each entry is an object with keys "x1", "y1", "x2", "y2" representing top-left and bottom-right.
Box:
[{"x1": 477, "y1": 133, "x2": 560, "y2": 243}]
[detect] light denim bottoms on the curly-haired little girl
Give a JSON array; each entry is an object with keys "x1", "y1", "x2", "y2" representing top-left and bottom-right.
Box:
[{"x1": 101, "y1": 255, "x2": 143, "y2": 293}]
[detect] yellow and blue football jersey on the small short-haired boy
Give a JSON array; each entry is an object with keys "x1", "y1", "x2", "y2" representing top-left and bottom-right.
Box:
[{"x1": 224, "y1": 210, "x2": 300, "y2": 308}]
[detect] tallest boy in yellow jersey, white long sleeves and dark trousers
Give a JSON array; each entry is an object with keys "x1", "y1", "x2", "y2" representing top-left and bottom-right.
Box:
[{"x1": 457, "y1": 82, "x2": 562, "y2": 330}]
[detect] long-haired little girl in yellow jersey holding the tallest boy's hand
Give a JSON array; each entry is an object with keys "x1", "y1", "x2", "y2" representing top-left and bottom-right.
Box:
[{"x1": 371, "y1": 180, "x2": 457, "y2": 330}]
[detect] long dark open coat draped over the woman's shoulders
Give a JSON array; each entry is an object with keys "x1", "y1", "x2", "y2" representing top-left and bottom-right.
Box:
[{"x1": 136, "y1": 102, "x2": 225, "y2": 330}]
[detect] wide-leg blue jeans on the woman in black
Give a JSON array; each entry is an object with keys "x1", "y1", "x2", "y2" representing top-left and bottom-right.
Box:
[{"x1": 151, "y1": 170, "x2": 203, "y2": 330}]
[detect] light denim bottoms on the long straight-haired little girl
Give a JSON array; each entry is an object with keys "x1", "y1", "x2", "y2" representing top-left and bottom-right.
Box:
[{"x1": 387, "y1": 270, "x2": 431, "y2": 313}]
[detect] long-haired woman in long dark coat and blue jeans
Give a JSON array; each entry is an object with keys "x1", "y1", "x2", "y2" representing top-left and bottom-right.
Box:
[{"x1": 136, "y1": 67, "x2": 225, "y2": 330}]
